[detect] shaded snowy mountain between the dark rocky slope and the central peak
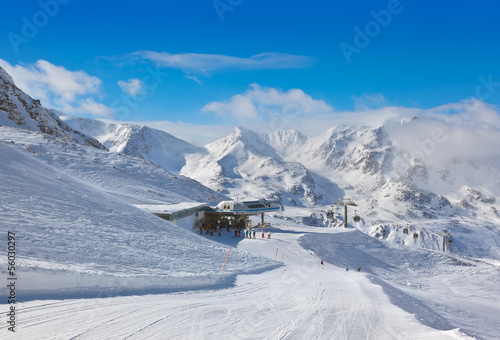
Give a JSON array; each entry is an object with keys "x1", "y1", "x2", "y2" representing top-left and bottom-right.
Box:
[{"x1": 59, "y1": 113, "x2": 202, "y2": 172}]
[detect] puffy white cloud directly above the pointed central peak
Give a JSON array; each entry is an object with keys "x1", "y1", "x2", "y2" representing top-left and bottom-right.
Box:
[{"x1": 202, "y1": 84, "x2": 333, "y2": 120}]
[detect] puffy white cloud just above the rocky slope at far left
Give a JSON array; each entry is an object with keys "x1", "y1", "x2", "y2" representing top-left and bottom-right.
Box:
[{"x1": 0, "y1": 59, "x2": 113, "y2": 117}]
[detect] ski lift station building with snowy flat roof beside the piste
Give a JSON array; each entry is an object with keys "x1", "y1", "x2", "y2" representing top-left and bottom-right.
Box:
[{"x1": 135, "y1": 199, "x2": 283, "y2": 230}]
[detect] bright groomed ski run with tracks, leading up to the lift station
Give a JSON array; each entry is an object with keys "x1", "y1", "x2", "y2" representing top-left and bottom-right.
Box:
[{"x1": 2, "y1": 219, "x2": 490, "y2": 339}]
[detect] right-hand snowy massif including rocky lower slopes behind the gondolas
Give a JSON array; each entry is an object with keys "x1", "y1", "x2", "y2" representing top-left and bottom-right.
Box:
[{"x1": 258, "y1": 119, "x2": 500, "y2": 258}]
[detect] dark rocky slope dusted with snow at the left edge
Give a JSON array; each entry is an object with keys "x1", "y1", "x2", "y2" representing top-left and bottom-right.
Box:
[{"x1": 0, "y1": 67, "x2": 105, "y2": 149}]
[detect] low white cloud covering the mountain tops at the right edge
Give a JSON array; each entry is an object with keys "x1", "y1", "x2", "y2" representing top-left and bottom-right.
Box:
[{"x1": 376, "y1": 99, "x2": 500, "y2": 166}]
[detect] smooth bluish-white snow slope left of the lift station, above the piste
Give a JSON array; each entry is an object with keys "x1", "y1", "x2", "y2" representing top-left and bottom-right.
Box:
[{"x1": 0, "y1": 127, "x2": 273, "y2": 298}]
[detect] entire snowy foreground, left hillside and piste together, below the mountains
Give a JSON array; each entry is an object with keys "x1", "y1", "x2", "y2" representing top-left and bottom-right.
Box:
[{"x1": 0, "y1": 127, "x2": 500, "y2": 339}]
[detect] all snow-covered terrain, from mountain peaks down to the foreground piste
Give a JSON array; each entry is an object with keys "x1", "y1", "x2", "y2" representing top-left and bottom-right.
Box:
[{"x1": 0, "y1": 65, "x2": 500, "y2": 339}]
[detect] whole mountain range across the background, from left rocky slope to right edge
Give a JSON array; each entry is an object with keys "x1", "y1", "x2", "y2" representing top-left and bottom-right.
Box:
[{"x1": 0, "y1": 65, "x2": 500, "y2": 231}]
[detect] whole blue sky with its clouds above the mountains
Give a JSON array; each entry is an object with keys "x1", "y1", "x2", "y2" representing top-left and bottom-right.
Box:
[{"x1": 0, "y1": 0, "x2": 500, "y2": 137}]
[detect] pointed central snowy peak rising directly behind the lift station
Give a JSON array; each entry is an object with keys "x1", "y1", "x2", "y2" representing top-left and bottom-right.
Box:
[{"x1": 181, "y1": 127, "x2": 338, "y2": 206}]
